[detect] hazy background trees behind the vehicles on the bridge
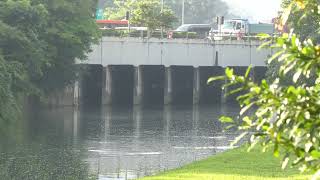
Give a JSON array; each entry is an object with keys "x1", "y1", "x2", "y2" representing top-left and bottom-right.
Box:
[{"x1": 105, "y1": 0, "x2": 232, "y2": 26}]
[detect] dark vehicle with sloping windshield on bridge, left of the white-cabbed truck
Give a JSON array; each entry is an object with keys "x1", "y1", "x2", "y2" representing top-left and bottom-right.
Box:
[{"x1": 168, "y1": 24, "x2": 212, "y2": 39}]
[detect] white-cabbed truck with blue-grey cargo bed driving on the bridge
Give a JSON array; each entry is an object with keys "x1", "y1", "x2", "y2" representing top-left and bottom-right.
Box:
[{"x1": 209, "y1": 19, "x2": 275, "y2": 40}]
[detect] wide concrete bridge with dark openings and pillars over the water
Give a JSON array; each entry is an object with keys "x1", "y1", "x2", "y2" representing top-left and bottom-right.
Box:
[{"x1": 52, "y1": 38, "x2": 272, "y2": 106}]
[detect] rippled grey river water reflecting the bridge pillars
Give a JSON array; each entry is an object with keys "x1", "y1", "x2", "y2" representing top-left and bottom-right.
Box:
[{"x1": 0, "y1": 106, "x2": 238, "y2": 180}]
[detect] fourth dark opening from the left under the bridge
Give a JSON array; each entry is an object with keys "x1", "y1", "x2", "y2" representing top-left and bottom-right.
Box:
[{"x1": 170, "y1": 66, "x2": 194, "y2": 105}]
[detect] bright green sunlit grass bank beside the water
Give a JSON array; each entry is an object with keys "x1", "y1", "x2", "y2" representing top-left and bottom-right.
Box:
[{"x1": 142, "y1": 147, "x2": 310, "y2": 180}]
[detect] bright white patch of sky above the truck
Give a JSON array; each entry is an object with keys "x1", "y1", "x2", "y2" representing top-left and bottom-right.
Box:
[{"x1": 223, "y1": 0, "x2": 281, "y2": 22}]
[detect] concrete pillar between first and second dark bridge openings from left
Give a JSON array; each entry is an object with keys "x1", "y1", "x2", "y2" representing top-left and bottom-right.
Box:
[{"x1": 102, "y1": 66, "x2": 112, "y2": 105}]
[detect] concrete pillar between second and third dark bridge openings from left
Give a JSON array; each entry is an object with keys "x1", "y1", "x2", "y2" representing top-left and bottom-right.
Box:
[{"x1": 133, "y1": 66, "x2": 143, "y2": 105}]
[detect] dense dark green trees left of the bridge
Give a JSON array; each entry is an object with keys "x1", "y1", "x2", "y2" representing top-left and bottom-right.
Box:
[{"x1": 0, "y1": 0, "x2": 99, "y2": 122}]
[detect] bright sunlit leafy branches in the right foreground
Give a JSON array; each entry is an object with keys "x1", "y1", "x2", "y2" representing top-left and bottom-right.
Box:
[{"x1": 209, "y1": 0, "x2": 320, "y2": 176}]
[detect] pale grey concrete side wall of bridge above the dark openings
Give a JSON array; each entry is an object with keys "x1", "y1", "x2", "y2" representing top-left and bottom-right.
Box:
[{"x1": 88, "y1": 37, "x2": 271, "y2": 67}]
